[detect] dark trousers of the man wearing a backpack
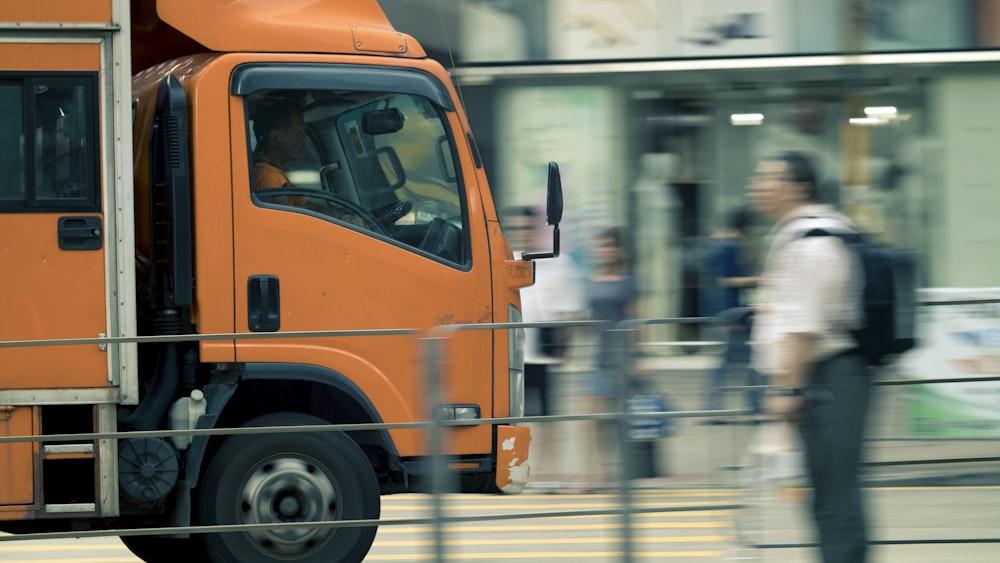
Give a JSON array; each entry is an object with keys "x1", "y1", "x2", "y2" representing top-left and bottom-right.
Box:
[{"x1": 799, "y1": 353, "x2": 871, "y2": 563}]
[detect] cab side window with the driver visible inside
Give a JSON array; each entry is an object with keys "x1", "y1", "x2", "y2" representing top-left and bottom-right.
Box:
[{"x1": 247, "y1": 90, "x2": 469, "y2": 265}]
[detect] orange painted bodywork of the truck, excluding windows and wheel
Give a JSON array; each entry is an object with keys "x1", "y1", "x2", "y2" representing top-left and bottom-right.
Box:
[{"x1": 0, "y1": 0, "x2": 534, "y2": 520}]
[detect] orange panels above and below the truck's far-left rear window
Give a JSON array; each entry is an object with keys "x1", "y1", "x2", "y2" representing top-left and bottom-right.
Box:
[{"x1": 0, "y1": 41, "x2": 107, "y2": 389}]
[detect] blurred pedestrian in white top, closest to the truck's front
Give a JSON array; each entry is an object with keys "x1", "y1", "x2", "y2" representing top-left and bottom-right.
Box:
[{"x1": 503, "y1": 206, "x2": 585, "y2": 487}]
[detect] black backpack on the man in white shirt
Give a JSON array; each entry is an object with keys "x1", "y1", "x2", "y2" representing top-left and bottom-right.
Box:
[{"x1": 803, "y1": 229, "x2": 917, "y2": 366}]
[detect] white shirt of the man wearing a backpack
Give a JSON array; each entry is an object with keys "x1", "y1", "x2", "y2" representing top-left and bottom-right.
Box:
[{"x1": 751, "y1": 205, "x2": 863, "y2": 375}]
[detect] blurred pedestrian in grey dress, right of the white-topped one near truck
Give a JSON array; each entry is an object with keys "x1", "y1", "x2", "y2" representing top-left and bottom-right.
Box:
[{"x1": 584, "y1": 228, "x2": 639, "y2": 485}]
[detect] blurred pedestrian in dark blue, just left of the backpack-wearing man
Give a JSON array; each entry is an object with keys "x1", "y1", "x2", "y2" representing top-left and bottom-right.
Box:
[{"x1": 703, "y1": 207, "x2": 763, "y2": 424}]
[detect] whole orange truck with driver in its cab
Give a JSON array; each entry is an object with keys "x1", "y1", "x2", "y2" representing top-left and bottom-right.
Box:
[{"x1": 0, "y1": 0, "x2": 562, "y2": 563}]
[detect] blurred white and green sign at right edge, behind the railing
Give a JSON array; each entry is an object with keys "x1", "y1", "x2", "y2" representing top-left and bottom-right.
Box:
[{"x1": 900, "y1": 288, "x2": 1000, "y2": 436}]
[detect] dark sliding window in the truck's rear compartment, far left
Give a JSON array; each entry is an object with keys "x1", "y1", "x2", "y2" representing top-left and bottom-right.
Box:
[{"x1": 0, "y1": 73, "x2": 100, "y2": 212}]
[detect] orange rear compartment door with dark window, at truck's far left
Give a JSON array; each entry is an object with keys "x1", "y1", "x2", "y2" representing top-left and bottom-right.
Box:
[{"x1": 0, "y1": 72, "x2": 108, "y2": 389}]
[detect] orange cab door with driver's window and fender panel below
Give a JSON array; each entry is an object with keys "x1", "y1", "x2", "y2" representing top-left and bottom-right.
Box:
[{"x1": 232, "y1": 65, "x2": 492, "y2": 456}]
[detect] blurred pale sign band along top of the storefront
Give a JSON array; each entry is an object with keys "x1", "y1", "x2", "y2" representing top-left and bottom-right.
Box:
[{"x1": 452, "y1": 0, "x2": 976, "y2": 63}]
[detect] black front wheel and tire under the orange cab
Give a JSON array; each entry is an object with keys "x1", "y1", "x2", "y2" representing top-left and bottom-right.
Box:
[{"x1": 198, "y1": 413, "x2": 381, "y2": 563}]
